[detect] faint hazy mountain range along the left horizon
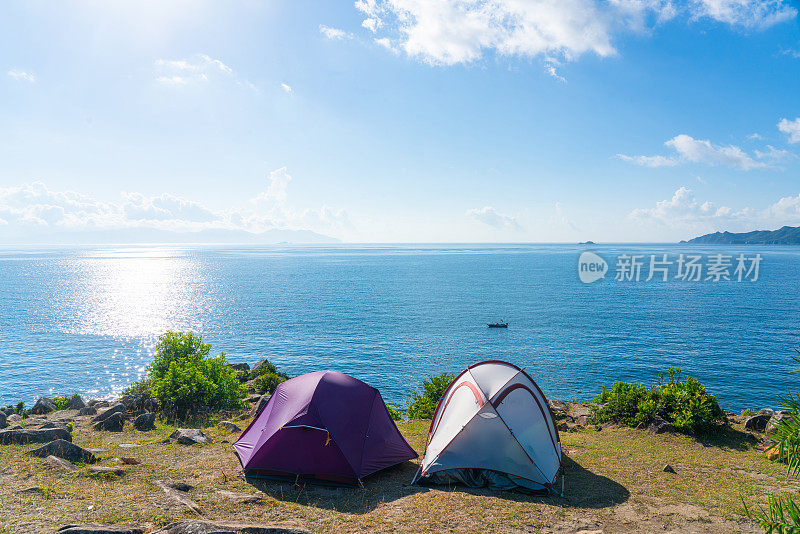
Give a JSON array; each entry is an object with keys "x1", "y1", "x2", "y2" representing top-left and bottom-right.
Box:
[{"x1": 0, "y1": 227, "x2": 339, "y2": 245}]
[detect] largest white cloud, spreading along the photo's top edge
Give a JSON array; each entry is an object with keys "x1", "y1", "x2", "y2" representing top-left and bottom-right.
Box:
[{"x1": 354, "y1": 0, "x2": 797, "y2": 65}]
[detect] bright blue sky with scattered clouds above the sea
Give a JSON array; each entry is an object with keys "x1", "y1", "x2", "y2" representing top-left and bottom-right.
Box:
[{"x1": 0, "y1": 0, "x2": 800, "y2": 242}]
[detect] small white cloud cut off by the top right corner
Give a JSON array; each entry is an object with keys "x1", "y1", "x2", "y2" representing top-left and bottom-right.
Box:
[{"x1": 692, "y1": 0, "x2": 797, "y2": 29}]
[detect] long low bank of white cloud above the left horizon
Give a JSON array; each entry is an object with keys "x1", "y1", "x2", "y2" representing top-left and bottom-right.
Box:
[{"x1": 0, "y1": 171, "x2": 352, "y2": 240}]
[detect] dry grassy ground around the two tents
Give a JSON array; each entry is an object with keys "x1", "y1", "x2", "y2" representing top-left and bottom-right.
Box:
[{"x1": 0, "y1": 413, "x2": 800, "y2": 534}]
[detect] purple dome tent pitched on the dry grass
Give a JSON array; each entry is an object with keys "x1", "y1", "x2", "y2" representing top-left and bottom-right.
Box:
[{"x1": 233, "y1": 371, "x2": 417, "y2": 484}]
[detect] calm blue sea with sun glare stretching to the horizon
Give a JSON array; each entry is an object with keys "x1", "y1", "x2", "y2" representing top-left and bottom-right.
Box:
[{"x1": 0, "y1": 245, "x2": 800, "y2": 410}]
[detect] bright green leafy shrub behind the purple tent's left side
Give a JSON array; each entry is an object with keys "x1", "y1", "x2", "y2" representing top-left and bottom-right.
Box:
[{"x1": 143, "y1": 332, "x2": 247, "y2": 415}]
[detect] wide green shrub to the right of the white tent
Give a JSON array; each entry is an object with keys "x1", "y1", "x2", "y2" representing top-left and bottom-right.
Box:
[{"x1": 593, "y1": 367, "x2": 726, "y2": 435}]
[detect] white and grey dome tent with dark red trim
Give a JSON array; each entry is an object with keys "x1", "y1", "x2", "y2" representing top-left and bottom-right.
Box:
[{"x1": 412, "y1": 360, "x2": 563, "y2": 493}]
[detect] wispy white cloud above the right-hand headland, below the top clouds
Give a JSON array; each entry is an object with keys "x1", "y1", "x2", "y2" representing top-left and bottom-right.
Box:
[{"x1": 617, "y1": 134, "x2": 770, "y2": 171}]
